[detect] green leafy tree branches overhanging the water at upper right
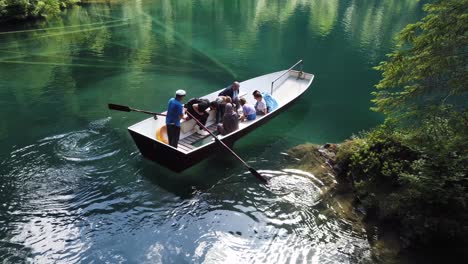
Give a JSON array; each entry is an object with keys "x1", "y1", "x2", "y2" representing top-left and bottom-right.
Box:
[{"x1": 373, "y1": 0, "x2": 468, "y2": 119}]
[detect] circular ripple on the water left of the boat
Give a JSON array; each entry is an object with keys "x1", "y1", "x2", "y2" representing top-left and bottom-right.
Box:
[{"x1": 54, "y1": 119, "x2": 120, "y2": 162}]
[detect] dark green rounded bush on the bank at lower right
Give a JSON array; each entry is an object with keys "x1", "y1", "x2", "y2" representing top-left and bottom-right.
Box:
[{"x1": 337, "y1": 120, "x2": 468, "y2": 244}]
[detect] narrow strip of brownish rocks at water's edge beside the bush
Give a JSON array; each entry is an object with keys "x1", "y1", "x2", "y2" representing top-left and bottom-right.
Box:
[{"x1": 287, "y1": 143, "x2": 408, "y2": 263}]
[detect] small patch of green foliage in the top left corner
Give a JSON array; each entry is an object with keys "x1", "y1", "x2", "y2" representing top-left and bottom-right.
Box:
[{"x1": 0, "y1": 0, "x2": 80, "y2": 21}]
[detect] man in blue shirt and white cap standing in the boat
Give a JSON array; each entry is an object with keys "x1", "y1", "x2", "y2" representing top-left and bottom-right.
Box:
[{"x1": 166, "y1": 90, "x2": 185, "y2": 148}]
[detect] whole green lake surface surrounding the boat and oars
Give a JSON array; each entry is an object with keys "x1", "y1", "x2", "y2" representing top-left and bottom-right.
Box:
[{"x1": 0, "y1": 0, "x2": 422, "y2": 263}]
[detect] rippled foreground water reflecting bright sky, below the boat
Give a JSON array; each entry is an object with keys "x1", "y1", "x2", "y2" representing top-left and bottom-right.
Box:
[{"x1": 0, "y1": 119, "x2": 368, "y2": 263}]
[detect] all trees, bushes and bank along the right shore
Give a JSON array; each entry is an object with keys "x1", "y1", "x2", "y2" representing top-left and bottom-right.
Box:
[{"x1": 289, "y1": 0, "x2": 468, "y2": 263}]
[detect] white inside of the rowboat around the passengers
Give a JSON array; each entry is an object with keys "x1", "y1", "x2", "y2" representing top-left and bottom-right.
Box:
[{"x1": 128, "y1": 70, "x2": 314, "y2": 154}]
